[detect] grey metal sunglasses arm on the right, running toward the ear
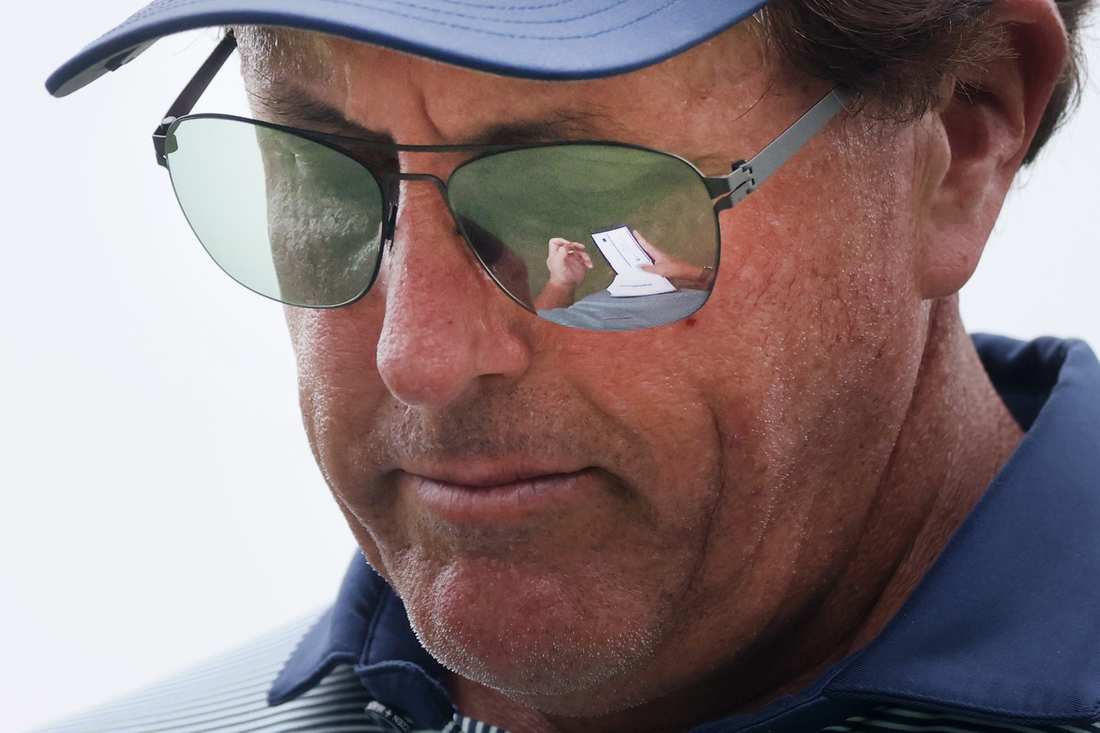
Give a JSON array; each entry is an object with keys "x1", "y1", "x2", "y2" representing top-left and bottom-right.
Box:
[{"x1": 705, "y1": 86, "x2": 854, "y2": 211}]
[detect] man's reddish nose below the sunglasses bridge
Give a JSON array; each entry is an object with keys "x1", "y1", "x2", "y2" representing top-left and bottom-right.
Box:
[{"x1": 377, "y1": 182, "x2": 531, "y2": 407}]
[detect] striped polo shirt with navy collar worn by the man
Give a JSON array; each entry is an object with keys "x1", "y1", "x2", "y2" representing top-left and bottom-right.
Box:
[{"x1": 34, "y1": 337, "x2": 1100, "y2": 733}]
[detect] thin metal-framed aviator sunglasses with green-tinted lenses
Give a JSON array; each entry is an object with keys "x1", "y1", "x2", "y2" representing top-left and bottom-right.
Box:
[{"x1": 153, "y1": 33, "x2": 850, "y2": 330}]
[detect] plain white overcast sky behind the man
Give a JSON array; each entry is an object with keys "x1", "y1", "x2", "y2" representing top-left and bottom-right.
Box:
[{"x1": 0, "y1": 0, "x2": 1100, "y2": 731}]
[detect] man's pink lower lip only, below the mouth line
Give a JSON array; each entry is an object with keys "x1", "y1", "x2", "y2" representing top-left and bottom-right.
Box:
[{"x1": 408, "y1": 471, "x2": 584, "y2": 525}]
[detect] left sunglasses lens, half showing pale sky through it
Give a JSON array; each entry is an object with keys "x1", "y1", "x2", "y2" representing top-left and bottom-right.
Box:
[{"x1": 167, "y1": 117, "x2": 383, "y2": 307}]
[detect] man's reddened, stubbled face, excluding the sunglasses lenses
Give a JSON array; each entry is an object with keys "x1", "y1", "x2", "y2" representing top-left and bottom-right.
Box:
[{"x1": 244, "y1": 28, "x2": 926, "y2": 714}]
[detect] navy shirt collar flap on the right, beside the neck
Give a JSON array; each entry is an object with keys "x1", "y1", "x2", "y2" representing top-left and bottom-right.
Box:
[{"x1": 825, "y1": 338, "x2": 1100, "y2": 722}]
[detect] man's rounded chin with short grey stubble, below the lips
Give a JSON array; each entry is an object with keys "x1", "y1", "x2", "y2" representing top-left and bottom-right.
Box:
[{"x1": 397, "y1": 550, "x2": 669, "y2": 715}]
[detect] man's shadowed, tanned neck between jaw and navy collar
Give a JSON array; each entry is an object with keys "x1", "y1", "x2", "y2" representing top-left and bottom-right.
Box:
[{"x1": 449, "y1": 298, "x2": 1023, "y2": 733}]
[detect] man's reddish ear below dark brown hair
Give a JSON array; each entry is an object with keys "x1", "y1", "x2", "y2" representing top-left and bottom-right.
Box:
[{"x1": 919, "y1": 0, "x2": 1068, "y2": 298}]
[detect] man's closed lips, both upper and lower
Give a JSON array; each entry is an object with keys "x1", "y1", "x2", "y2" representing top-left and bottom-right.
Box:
[{"x1": 400, "y1": 467, "x2": 589, "y2": 526}]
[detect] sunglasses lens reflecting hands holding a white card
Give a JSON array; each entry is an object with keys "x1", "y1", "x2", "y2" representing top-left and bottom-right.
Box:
[{"x1": 448, "y1": 144, "x2": 718, "y2": 330}]
